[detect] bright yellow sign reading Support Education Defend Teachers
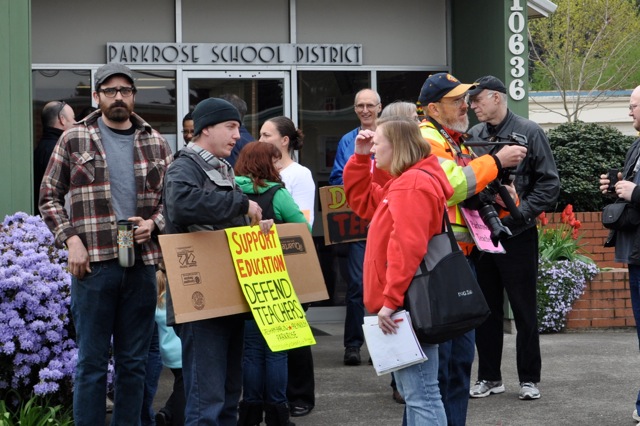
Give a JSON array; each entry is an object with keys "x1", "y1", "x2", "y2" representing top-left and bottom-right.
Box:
[{"x1": 225, "y1": 226, "x2": 316, "y2": 352}]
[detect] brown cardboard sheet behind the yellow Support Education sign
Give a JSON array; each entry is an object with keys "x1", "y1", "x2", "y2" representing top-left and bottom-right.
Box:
[{"x1": 160, "y1": 223, "x2": 329, "y2": 324}]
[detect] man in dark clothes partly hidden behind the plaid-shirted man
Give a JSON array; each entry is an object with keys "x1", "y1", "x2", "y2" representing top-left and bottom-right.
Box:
[{"x1": 33, "y1": 101, "x2": 75, "y2": 214}]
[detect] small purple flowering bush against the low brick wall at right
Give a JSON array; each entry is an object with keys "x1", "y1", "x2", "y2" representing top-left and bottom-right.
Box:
[{"x1": 537, "y1": 257, "x2": 598, "y2": 333}]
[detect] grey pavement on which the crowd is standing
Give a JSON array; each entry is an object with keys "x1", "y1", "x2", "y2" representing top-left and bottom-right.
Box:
[{"x1": 149, "y1": 308, "x2": 640, "y2": 426}]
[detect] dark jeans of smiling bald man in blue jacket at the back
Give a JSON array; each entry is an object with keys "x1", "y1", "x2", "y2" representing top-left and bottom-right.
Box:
[{"x1": 341, "y1": 241, "x2": 365, "y2": 348}]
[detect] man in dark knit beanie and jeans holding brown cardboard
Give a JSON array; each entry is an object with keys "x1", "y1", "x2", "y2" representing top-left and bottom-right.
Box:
[{"x1": 164, "y1": 98, "x2": 273, "y2": 425}]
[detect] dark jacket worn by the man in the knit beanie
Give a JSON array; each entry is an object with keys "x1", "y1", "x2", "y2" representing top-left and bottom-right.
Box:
[{"x1": 164, "y1": 148, "x2": 249, "y2": 234}]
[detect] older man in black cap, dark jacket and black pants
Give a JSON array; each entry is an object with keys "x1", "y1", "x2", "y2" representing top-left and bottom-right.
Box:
[{"x1": 469, "y1": 75, "x2": 560, "y2": 400}]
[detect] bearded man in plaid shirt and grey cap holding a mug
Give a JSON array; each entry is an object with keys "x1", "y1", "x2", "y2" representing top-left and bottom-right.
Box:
[{"x1": 40, "y1": 63, "x2": 172, "y2": 426}]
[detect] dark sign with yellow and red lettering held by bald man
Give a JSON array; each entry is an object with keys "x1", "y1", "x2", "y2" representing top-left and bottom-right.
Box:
[{"x1": 320, "y1": 185, "x2": 369, "y2": 245}]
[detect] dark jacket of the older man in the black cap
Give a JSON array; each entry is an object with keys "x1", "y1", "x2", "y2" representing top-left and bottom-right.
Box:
[{"x1": 469, "y1": 111, "x2": 560, "y2": 236}]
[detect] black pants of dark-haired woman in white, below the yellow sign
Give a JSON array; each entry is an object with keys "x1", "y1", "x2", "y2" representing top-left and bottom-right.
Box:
[{"x1": 287, "y1": 346, "x2": 316, "y2": 408}]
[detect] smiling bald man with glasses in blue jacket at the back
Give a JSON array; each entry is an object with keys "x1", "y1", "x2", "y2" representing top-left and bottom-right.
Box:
[{"x1": 329, "y1": 89, "x2": 382, "y2": 365}]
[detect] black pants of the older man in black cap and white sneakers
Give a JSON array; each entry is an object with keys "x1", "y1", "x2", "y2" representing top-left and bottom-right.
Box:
[{"x1": 475, "y1": 227, "x2": 542, "y2": 383}]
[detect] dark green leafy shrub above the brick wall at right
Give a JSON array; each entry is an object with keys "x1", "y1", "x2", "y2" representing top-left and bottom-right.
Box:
[{"x1": 548, "y1": 121, "x2": 635, "y2": 212}]
